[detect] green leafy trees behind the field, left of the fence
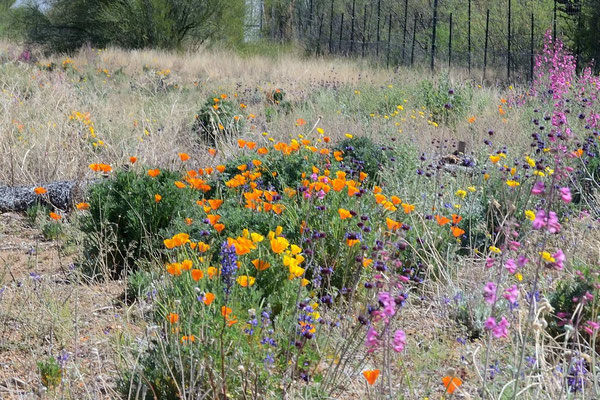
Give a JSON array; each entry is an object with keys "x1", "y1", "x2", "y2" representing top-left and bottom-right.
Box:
[{"x1": 13, "y1": 0, "x2": 243, "y2": 52}]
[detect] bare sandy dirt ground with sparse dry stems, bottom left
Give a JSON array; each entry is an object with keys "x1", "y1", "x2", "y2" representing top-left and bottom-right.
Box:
[{"x1": 0, "y1": 213, "x2": 132, "y2": 399}]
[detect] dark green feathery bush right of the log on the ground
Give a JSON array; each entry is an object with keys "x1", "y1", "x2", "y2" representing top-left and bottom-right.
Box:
[{"x1": 81, "y1": 170, "x2": 203, "y2": 277}]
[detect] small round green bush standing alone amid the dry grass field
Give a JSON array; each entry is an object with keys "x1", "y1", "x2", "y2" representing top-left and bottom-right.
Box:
[{"x1": 192, "y1": 97, "x2": 243, "y2": 145}]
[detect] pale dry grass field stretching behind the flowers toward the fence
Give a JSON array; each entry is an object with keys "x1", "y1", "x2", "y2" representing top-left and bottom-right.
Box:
[{"x1": 0, "y1": 39, "x2": 521, "y2": 185}]
